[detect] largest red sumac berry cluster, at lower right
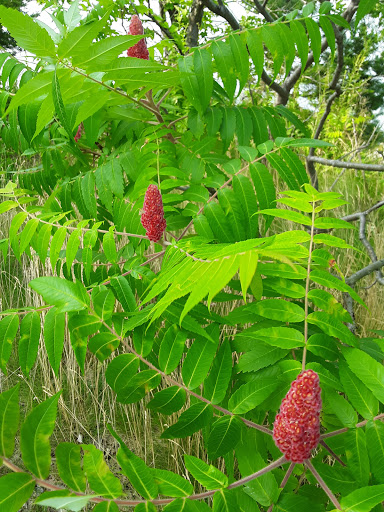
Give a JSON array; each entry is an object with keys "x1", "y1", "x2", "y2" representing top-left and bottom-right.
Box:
[{"x1": 273, "y1": 370, "x2": 321, "y2": 463}]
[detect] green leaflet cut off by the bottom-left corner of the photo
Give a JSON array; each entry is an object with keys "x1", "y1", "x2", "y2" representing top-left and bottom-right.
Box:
[{"x1": 0, "y1": 473, "x2": 36, "y2": 512}]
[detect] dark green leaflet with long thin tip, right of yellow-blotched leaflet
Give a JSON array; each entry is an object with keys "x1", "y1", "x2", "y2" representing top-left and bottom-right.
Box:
[{"x1": 108, "y1": 426, "x2": 159, "y2": 500}]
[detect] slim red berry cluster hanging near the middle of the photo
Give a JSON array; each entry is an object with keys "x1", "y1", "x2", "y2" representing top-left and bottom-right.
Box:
[{"x1": 141, "y1": 185, "x2": 167, "y2": 242}]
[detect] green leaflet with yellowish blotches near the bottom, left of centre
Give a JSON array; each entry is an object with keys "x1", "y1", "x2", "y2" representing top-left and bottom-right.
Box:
[{"x1": 82, "y1": 444, "x2": 123, "y2": 498}]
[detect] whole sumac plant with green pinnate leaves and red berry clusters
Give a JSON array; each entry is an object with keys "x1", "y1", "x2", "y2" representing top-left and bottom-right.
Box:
[{"x1": 0, "y1": 1, "x2": 384, "y2": 512}]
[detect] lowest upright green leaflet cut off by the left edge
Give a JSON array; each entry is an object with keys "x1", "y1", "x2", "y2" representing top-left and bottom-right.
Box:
[{"x1": 0, "y1": 384, "x2": 20, "y2": 457}]
